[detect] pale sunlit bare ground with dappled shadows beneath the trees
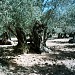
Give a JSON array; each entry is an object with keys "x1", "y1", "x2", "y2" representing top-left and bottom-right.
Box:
[{"x1": 0, "y1": 38, "x2": 75, "y2": 75}]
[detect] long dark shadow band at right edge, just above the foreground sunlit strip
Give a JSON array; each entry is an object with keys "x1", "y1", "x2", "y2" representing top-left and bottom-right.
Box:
[{"x1": 48, "y1": 50, "x2": 75, "y2": 60}]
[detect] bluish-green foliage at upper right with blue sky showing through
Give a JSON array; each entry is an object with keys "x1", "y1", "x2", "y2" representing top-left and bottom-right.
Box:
[{"x1": 43, "y1": 0, "x2": 75, "y2": 32}]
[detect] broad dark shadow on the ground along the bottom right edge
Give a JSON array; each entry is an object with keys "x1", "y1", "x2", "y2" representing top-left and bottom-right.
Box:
[{"x1": 29, "y1": 64, "x2": 75, "y2": 75}]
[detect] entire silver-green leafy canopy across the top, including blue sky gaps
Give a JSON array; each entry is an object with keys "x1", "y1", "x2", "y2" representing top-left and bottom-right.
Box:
[{"x1": 0, "y1": 0, "x2": 75, "y2": 33}]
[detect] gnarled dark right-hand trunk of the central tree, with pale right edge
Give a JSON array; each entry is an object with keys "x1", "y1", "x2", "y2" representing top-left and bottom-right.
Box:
[{"x1": 32, "y1": 23, "x2": 47, "y2": 53}]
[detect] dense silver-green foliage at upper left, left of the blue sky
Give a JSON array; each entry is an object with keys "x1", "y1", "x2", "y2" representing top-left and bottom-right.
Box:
[{"x1": 0, "y1": 0, "x2": 42, "y2": 32}]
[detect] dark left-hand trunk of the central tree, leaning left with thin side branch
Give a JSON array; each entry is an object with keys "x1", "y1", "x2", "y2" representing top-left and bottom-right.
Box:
[{"x1": 8, "y1": 27, "x2": 29, "y2": 54}]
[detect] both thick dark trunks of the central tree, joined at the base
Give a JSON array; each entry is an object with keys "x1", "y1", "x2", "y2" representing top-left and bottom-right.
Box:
[{"x1": 9, "y1": 23, "x2": 47, "y2": 53}]
